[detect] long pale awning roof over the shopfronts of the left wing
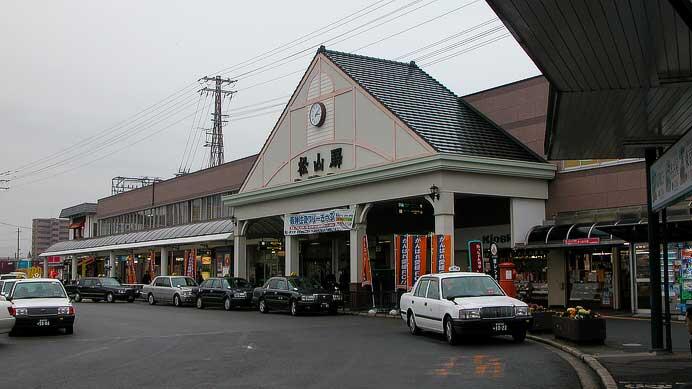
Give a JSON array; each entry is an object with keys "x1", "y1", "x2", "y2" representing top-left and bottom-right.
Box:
[{"x1": 40, "y1": 219, "x2": 233, "y2": 257}]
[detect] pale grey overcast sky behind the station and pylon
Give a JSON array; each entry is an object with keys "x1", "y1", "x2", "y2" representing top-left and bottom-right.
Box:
[{"x1": 0, "y1": 0, "x2": 539, "y2": 257}]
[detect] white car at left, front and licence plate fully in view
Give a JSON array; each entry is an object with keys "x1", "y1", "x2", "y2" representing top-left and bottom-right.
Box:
[{"x1": 5, "y1": 278, "x2": 76, "y2": 335}]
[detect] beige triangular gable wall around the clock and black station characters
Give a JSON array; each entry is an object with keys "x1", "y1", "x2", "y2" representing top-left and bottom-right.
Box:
[{"x1": 241, "y1": 55, "x2": 434, "y2": 192}]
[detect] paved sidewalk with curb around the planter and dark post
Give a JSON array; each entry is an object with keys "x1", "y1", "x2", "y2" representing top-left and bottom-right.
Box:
[{"x1": 534, "y1": 317, "x2": 692, "y2": 388}]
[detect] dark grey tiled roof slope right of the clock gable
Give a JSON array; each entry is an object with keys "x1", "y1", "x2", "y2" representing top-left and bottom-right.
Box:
[{"x1": 320, "y1": 48, "x2": 543, "y2": 162}]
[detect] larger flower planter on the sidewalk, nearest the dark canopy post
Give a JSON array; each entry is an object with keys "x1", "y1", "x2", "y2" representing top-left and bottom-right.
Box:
[{"x1": 553, "y1": 306, "x2": 606, "y2": 343}]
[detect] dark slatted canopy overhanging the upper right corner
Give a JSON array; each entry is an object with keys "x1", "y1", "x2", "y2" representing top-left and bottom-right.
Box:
[{"x1": 487, "y1": 0, "x2": 692, "y2": 160}]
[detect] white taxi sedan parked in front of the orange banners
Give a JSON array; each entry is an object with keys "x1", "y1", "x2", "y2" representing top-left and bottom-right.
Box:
[{"x1": 399, "y1": 271, "x2": 531, "y2": 344}]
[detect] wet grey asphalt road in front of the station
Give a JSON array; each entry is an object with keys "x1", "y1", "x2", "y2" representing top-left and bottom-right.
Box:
[{"x1": 0, "y1": 302, "x2": 579, "y2": 389}]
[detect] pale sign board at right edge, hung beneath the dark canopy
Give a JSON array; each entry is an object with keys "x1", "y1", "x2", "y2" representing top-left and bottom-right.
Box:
[{"x1": 649, "y1": 131, "x2": 692, "y2": 211}]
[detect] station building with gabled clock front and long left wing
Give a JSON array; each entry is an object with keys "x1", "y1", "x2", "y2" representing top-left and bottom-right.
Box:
[{"x1": 46, "y1": 48, "x2": 557, "y2": 304}]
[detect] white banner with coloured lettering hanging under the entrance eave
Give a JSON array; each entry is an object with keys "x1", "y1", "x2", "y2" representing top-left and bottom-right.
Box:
[{"x1": 284, "y1": 208, "x2": 355, "y2": 235}]
